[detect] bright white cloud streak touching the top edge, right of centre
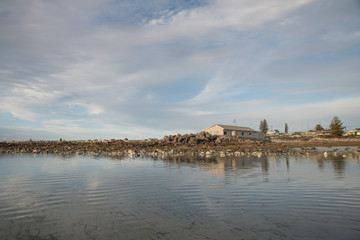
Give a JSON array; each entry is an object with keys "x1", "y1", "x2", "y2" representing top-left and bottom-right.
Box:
[{"x1": 146, "y1": 0, "x2": 313, "y2": 31}]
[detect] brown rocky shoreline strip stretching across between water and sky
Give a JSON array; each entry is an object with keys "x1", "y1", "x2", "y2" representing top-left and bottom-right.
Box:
[{"x1": 0, "y1": 133, "x2": 360, "y2": 158}]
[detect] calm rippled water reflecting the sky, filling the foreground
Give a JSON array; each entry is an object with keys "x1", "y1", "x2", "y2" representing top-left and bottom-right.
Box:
[{"x1": 0, "y1": 155, "x2": 360, "y2": 240}]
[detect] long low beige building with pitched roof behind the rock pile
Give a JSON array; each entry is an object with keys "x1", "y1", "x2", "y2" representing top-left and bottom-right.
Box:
[{"x1": 202, "y1": 124, "x2": 265, "y2": 140}]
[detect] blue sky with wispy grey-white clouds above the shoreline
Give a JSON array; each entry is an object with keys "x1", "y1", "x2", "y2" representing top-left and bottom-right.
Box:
[{"x1": 0, "y1": 0, "x2": 360, "y2": 141}]
